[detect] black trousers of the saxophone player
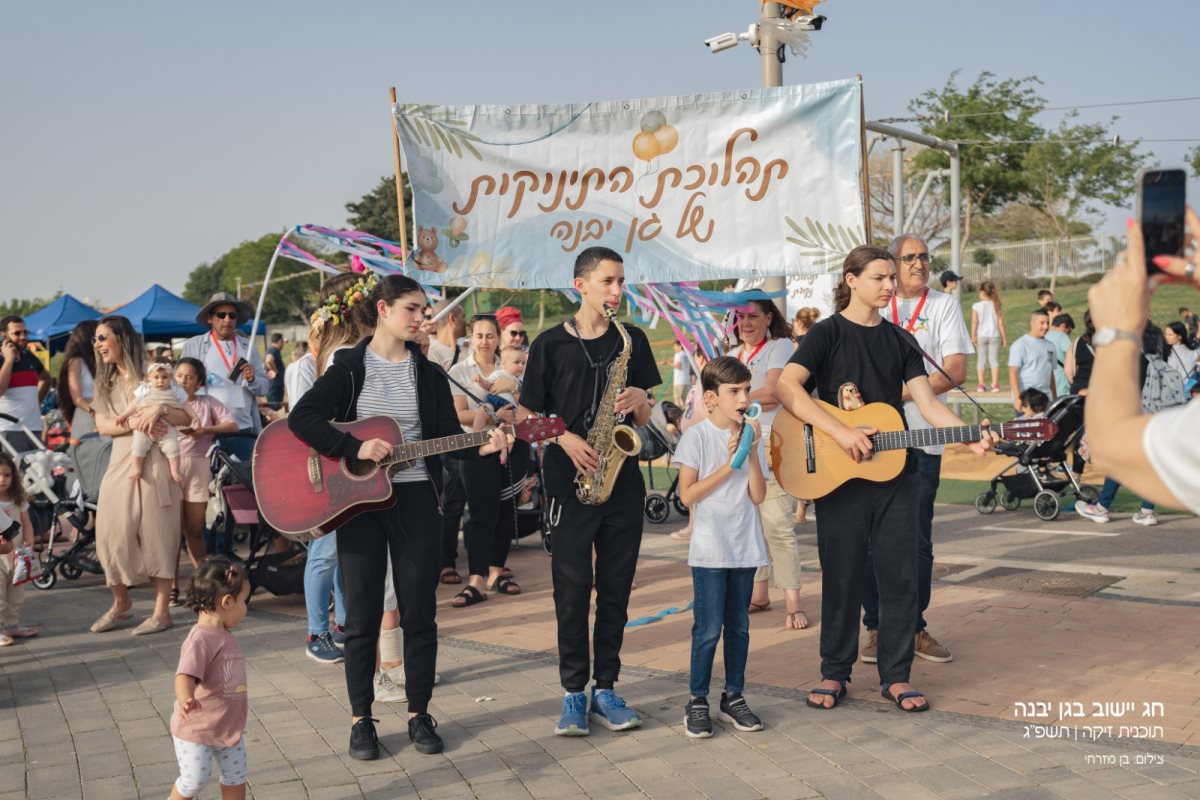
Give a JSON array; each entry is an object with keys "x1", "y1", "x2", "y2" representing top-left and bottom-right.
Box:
[{"x1": 551, "y1": 485, "x2": 648, "y2": 692}]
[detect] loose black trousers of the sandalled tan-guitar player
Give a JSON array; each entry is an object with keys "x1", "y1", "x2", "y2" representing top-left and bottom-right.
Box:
[{"x1": 816, "y1": 471, "x2": 919, "y2": 684}]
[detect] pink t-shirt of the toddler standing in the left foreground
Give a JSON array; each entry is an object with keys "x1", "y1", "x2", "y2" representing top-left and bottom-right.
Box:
[{"x1": 170, "y1": 625, "x2": 250, "y2": 747}]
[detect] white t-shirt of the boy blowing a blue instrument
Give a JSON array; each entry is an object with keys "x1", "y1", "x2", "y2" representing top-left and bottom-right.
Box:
[{"x1": 672, "y1": 419, "x2": 768, "y2": 570}]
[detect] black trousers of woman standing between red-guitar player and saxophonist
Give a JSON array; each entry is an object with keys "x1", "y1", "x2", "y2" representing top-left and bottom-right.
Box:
[{"x1": 462, "y1": 453, "x2": 516, "y2": 577}]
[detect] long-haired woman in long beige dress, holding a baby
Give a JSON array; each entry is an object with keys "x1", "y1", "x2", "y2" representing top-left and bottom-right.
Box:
[{"x1": 91, "y1": 315, "x2": 191, "y2": 636}]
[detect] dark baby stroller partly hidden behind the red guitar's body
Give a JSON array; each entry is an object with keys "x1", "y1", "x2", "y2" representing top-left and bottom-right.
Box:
[{"x1": 205, "y1": 433, "x2": 308, "y2": 604}]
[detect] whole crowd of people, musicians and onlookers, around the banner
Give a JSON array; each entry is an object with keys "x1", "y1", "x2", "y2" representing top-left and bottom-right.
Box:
[{"x1": 0, "y1": 216, "x2": 1200, "y2": 798}]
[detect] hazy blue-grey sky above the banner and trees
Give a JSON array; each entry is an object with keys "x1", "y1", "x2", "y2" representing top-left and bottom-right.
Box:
[{"x1": 0, "y1": 0, "x2": 1200, "y2": 306}]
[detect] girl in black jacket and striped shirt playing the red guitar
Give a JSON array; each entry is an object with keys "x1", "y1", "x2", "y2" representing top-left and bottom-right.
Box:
[{"x1": 286, "y1": 275, "x2": 508, "y2": 760}]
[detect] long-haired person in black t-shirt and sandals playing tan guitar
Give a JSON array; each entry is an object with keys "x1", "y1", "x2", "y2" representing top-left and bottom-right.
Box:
[{"x1": 773, "y1": 245, "x2": 992, "y2": 711}]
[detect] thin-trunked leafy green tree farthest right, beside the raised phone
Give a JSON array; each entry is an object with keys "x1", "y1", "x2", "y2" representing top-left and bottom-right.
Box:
[{"x1": 1025, "y1": 112, "x2": 1147, "y2": 291}]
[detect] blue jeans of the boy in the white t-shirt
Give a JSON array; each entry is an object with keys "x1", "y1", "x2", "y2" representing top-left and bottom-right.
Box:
[{"x1": 689, "y1": 566, "x2": 755, "y2": 697}]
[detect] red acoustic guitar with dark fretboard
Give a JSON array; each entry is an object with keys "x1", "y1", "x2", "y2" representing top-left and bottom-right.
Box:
[{"x1": 252, "y1": 416, "x2": 565, "y2": 541}]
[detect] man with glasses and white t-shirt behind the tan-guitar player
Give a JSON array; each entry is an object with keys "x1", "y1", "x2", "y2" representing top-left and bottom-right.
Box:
[{"x1": 862, "y1": 234, "x2": 974, "y2": 663}]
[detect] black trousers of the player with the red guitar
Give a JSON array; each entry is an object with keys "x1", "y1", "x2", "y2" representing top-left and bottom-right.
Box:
[{"x1": 337, "y1": 481, "x2": 442, "y2": 717}]
